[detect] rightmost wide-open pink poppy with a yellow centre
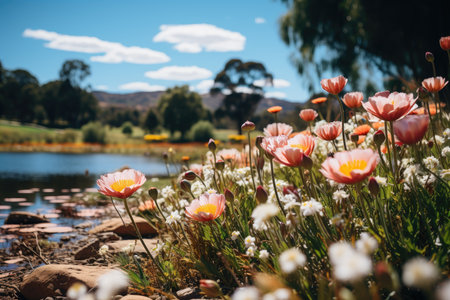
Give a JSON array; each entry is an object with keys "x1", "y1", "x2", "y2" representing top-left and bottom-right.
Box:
[{"x1": 320, "y1": 149, "x2": 379, "y2": 184}]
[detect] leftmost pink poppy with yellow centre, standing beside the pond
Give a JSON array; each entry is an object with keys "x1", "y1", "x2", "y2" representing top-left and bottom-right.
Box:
[{"x1": 97, "y1": 169, "x2": 147, "y2": 199}]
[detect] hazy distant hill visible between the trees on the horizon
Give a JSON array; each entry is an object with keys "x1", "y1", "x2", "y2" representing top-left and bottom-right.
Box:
[{"x1": 93, "y1": 91, "x2": 303, "y2": 114}]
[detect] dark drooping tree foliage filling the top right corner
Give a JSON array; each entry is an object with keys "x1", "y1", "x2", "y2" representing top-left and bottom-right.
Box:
[{"x1": 280, "y1": 0, "x2": 450, "y2": 89}]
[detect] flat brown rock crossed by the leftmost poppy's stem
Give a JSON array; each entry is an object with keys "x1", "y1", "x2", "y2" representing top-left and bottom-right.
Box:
[{"x1": 89, "y1": 217, "x2": 156, "y2": 237}]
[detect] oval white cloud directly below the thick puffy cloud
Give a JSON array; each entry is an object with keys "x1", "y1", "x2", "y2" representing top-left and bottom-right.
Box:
[{"x1": 145, "y1": 66, "x2": 212, "y2": 81}]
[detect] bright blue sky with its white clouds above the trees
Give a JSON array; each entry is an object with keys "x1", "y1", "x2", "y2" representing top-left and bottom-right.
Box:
[{"x1": 0, "y1": 0, "x2": 320, "y2": 102}]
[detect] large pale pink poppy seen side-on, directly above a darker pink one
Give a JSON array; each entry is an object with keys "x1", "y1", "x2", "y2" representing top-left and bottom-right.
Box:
[{"x1": 362, "y1": 91, "x2": 417, "y2": 121}]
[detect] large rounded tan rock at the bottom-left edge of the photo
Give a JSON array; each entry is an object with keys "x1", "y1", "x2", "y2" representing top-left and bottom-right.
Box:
[{"x1": 19, "y1": 264, "x2": 111, "y2": 300}]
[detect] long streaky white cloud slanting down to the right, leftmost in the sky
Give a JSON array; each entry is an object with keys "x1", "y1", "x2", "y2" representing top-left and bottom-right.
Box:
[{"x1": 23, "y1": 29, "x2": 170, "y2": 64}]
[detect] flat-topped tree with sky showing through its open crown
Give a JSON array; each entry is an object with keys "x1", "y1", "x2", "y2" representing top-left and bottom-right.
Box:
[{"x1": 211, "y1": 59, "x2": 273, "y2": 133}]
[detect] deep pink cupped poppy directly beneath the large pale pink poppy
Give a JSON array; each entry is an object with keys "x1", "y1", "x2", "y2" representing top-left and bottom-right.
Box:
[{"x1": 394, "y1": 115, "x2": 430, "y2": 145}]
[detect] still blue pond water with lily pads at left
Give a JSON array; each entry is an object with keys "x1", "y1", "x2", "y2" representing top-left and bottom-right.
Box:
[{"x1": 0, "y1": 153, "x2": 175, "y2": 226}]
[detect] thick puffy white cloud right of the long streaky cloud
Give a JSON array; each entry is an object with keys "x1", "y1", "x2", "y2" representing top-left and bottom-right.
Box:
[{"x1": 153, "y1": 24, "x2": 246, "y2": 53}]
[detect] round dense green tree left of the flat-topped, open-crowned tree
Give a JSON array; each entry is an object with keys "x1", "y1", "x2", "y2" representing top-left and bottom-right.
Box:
[{"x1": 158, "y1": 85, "x2": 205, "y2": 138}]
